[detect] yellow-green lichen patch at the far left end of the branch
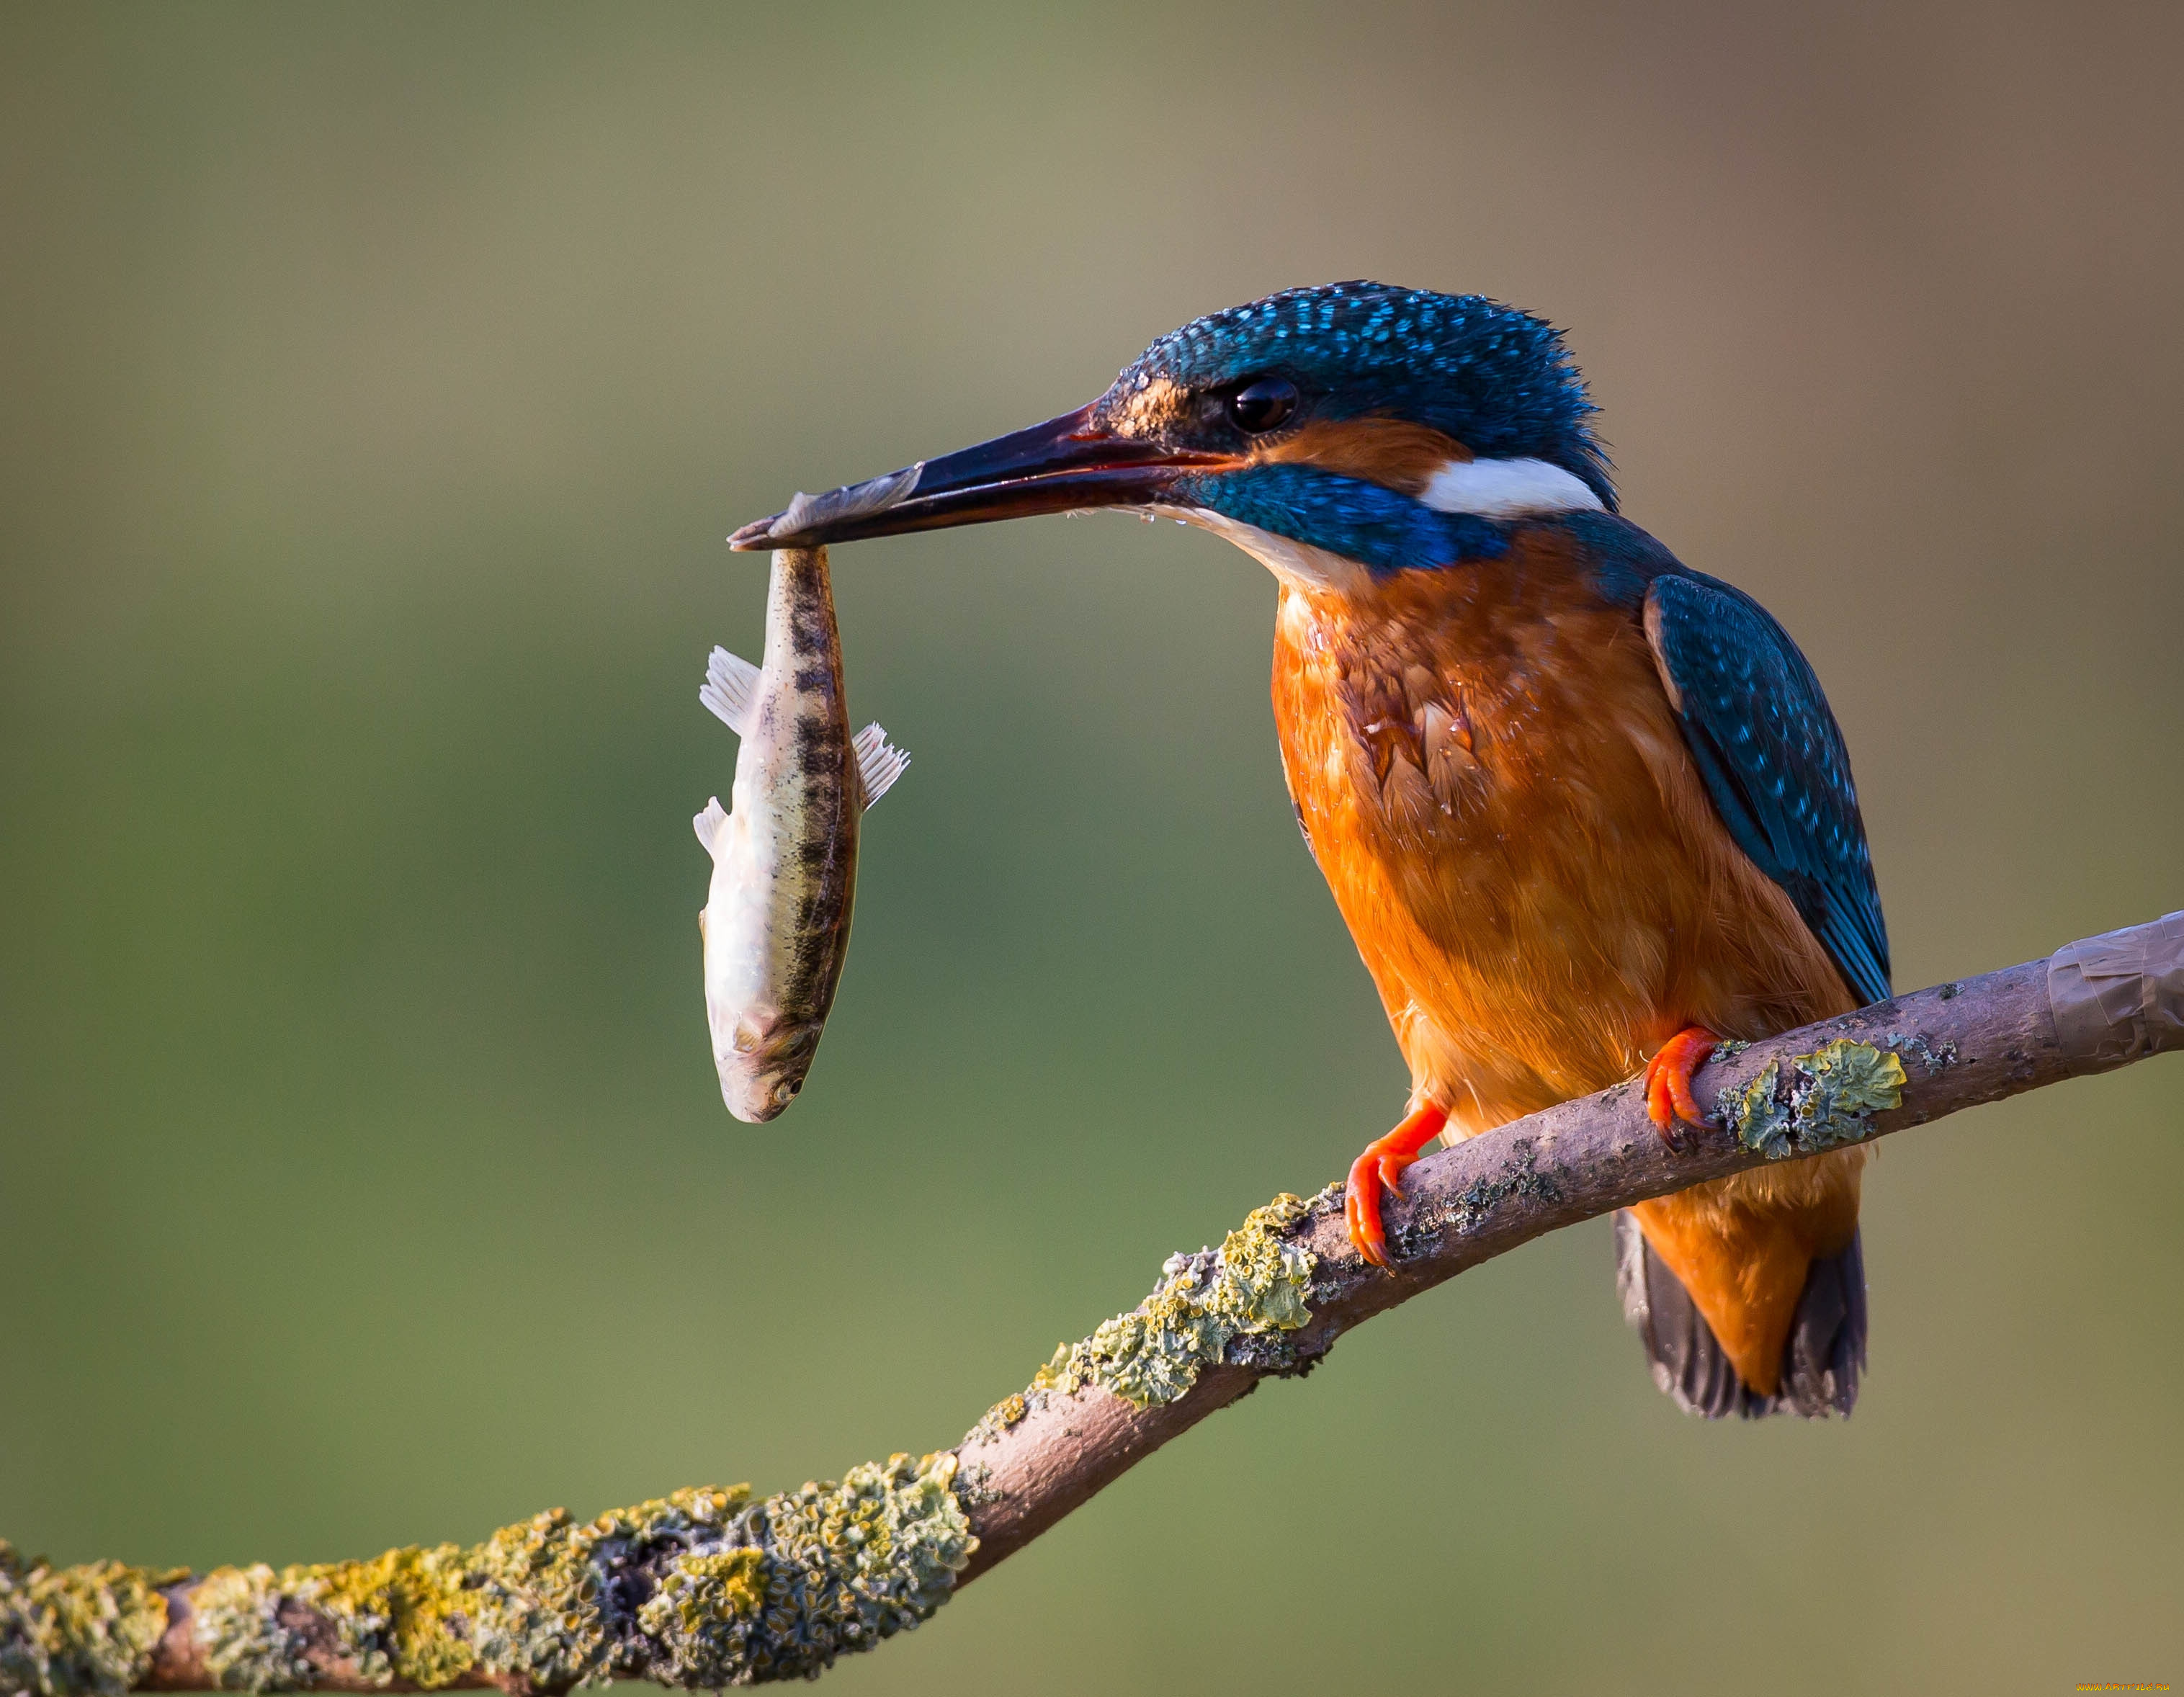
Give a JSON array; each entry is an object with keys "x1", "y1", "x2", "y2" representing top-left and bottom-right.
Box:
[{"x1": 0, "y1": 1538, "x2": 186, "y2": 1697}]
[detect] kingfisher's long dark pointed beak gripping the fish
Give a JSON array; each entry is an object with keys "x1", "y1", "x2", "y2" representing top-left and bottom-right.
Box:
[{"x1": 728, "y1": 406, "x2": 1238, "y2": 548}]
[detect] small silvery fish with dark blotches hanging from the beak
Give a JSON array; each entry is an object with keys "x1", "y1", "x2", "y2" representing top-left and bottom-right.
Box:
[{"x1": 692, "y1": 548, "x2": 908, "y2": 1125}]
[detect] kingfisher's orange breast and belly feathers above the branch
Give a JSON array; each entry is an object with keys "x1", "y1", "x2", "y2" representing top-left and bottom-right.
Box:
[{"x1": 1274, "y1": 531, "x2": 1854, "y2": 1136}]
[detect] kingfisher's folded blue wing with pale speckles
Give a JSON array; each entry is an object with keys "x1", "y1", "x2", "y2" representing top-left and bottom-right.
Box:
[{"x1": 1647, "y1": 568, "x2": 1889, "y2": 1003}]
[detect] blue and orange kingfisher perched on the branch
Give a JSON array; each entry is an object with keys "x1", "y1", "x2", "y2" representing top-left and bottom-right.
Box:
[{"x1": 730, "y1": 282, "x2": 1889, "y2": 1418}]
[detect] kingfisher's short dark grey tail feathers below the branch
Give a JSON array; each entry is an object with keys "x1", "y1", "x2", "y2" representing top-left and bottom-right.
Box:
[{"x1": 1616, "y1": 1208, "x2": 1865, "y2": 1420}]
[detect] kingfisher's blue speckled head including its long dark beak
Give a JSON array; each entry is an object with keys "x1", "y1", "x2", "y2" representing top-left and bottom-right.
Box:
[{"x1": 734, "y1": 282, "x2": 1616, "y2": 576}]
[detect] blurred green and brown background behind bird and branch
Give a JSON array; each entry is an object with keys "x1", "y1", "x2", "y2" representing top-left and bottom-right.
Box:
[{"x1": 0, "y1": 0, "x2": 2184, "y2": 1697}]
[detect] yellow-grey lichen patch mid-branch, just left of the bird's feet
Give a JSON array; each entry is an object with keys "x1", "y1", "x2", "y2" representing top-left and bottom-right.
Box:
[{"x1": 1026, "y1": 1195, "x2": 1315, "y2": 1424}]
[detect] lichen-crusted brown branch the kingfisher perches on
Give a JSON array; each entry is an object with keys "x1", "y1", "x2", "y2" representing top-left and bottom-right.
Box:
[{"x1": 0, "y1": 913, "x2": 2184, "y2": 1697}]
